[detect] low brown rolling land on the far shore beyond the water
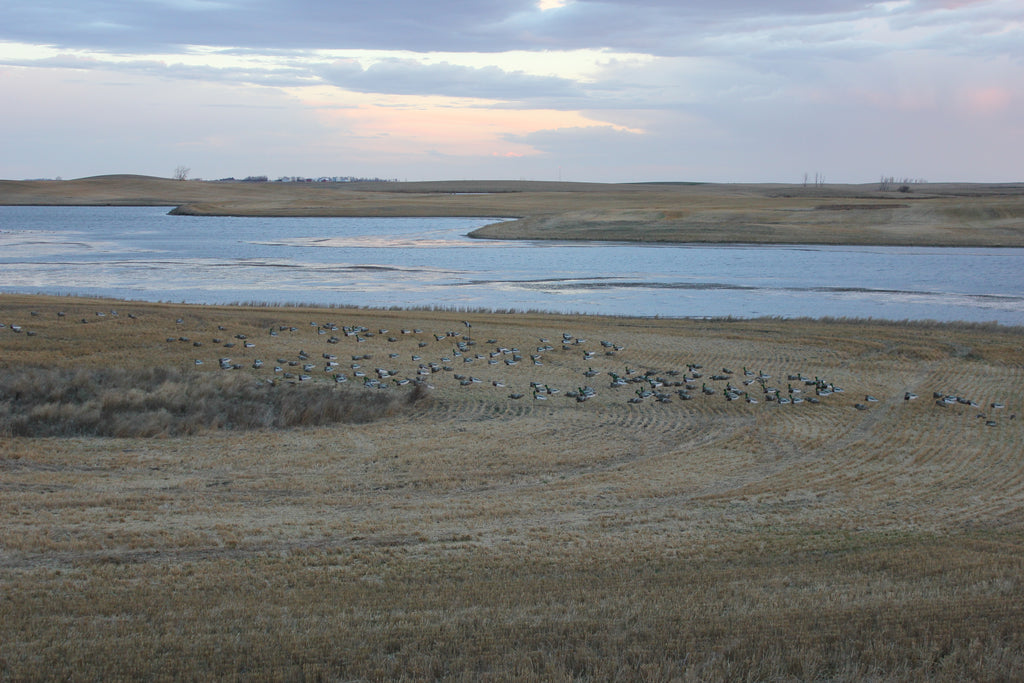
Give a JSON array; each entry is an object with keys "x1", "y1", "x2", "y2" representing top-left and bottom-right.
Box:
[{"x1": 6, "y1": 175, "x2": 1024, "y2": 247}]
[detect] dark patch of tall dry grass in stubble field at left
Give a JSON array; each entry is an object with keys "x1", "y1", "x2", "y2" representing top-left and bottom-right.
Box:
[{"x1": 0, "y1": 368, "x2": 425, "y2": 437}]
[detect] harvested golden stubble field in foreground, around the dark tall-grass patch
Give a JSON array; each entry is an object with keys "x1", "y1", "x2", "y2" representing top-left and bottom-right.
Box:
[{"x1": 0, "y1": 295, "x2": 1024, "y2": 681}]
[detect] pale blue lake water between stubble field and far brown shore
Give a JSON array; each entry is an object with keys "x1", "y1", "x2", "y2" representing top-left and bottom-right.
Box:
[{"x1": 0, "y1": 207, "x2": 1024, "y2": 325}]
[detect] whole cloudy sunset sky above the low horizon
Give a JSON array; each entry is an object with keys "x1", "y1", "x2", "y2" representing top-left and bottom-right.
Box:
[{"x1": 0, "y1": 0, "x2": 1024, "y2": 182}]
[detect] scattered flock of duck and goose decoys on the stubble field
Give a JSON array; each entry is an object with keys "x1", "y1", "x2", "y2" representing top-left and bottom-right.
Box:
[{"x1": 0, "y1": 310, "x2": 1016, "y2": 426}]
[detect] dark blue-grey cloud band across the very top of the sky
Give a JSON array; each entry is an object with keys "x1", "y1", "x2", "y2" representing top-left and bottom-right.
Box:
[{"x1": 6, "y1": 0, "x2": 1021, "y2": 56}]
